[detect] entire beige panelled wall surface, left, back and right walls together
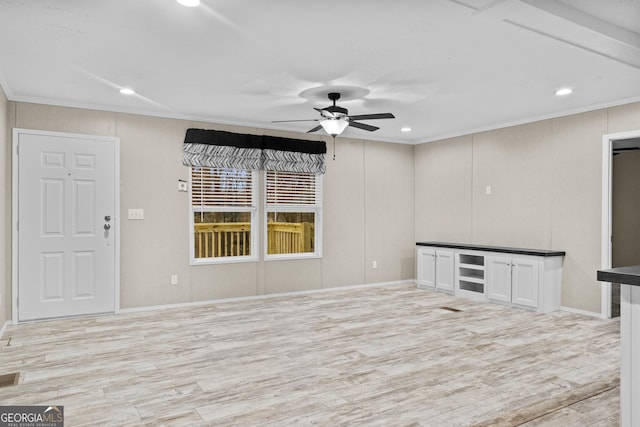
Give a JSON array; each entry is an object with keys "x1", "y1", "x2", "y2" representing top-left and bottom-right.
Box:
[{"x1": 6, "y1": 94, "x2": 640, "y2": 320}]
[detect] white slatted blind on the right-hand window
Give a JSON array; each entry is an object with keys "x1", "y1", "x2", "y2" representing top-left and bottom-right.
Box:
[{"x1": 267, "y1": 171, "x2": 321, "y2": 206}]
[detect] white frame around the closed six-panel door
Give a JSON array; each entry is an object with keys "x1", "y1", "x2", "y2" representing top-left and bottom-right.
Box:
[{"x1": 11, "y1": 128, "x2": 122, "y2": 325}]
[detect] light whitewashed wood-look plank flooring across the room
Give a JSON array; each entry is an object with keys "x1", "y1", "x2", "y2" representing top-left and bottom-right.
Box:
[{"x1": 0, "y1": 284, "x2": 620, "y2": 427}]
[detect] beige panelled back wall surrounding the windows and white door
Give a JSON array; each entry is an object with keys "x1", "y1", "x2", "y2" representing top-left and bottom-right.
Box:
[{"x1": 4, "y1": 102, "x2": 414, "y2": 308}]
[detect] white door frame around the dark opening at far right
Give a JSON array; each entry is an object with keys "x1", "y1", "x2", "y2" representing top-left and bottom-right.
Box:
[{"x1": 600, "y1": 129, "x2": 640, "y2": 319}]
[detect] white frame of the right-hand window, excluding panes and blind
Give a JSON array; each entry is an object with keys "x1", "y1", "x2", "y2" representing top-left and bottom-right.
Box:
[{"x1": 262, "y1": 170, "x2": 323, "y2": 261}]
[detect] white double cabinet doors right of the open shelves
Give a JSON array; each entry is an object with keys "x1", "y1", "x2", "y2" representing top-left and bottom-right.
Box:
[{"x1": 487, "y1": 256, "x2": 543, "y2": 308}]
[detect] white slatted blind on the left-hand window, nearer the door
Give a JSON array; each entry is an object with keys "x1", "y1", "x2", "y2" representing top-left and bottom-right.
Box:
[{"x1": 191, "y1": 167, "x2": 253, "y2": 207}]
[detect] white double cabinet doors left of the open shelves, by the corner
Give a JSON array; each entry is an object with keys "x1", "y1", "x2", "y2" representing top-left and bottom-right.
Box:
[{"x1": 417, "y1": 248, "x2": 454, "y2": 292}]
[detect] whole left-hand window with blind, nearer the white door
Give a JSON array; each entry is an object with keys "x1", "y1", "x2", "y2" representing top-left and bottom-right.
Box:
[{"x1": 191, "y1": 166, "x2": 258, "y2": 263}]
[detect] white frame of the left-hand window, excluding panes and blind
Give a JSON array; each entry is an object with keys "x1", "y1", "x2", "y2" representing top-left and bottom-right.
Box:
[{"x1": 188, "y1": 166, "x2": 260, "y2": 265}]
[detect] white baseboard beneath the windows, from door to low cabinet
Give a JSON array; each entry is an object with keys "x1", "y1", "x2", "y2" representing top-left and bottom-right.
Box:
[{"x1": 118, "y1": 279, "x2": 415, "y2": 313}]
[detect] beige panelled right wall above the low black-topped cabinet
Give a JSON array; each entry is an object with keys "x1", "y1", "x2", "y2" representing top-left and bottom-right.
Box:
[{"x1": 415, "y1": 103, "x2": 640, "y2": 312}]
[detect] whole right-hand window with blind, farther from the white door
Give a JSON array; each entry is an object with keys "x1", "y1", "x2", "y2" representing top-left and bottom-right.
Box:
[{"x1": 265, "y1": 171, "x2": 322, "y2": 259}]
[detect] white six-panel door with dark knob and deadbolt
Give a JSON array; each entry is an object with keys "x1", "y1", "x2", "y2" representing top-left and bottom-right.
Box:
[{"x1": 14, "y1": 129, "x2": 117, "y2": 321}]
